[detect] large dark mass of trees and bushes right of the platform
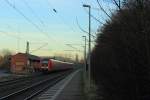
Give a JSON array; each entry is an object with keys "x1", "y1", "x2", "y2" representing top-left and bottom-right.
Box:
[{"x1": 91, "y1": 0, "x2": 150, "y2": 100}]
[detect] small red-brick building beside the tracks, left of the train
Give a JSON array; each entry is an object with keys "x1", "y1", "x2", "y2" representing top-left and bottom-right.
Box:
[{"x1": 11, "y1": 53, "x2": 40, "y2": 74}]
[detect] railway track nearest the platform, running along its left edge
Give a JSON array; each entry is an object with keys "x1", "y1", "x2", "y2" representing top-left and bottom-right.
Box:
[{"x1": 0, "y1": 71, "x2": 72, "y2": 100}]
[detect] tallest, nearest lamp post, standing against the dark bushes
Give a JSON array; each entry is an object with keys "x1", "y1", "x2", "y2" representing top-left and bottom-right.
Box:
[{"x1": 83, "y1": 4, "x2": 91, "y2": 87}]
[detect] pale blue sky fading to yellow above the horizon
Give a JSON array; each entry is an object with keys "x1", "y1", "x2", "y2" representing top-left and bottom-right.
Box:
[{"x1": 0, "y1": 0, "x2": 114, "y2": 59}]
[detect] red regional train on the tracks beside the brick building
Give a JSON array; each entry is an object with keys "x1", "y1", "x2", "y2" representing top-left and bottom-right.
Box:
[{"x1": 41, "y1": 58, "x2": 73, "y2": 72}]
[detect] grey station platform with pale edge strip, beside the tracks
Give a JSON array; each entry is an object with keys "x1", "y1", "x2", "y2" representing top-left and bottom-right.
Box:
[{"x1": 38, "y1": 69, "x2": 85, "y2": 100}]
